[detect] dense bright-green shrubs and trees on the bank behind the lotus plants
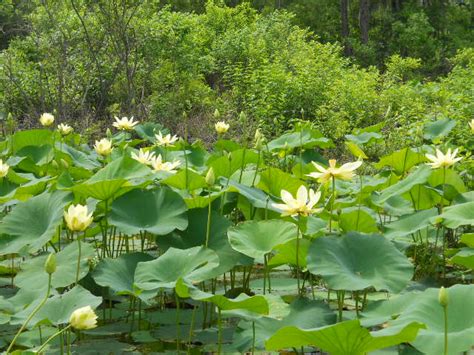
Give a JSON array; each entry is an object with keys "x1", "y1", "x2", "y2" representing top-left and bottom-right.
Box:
[{"x1": 0, "y1": 0, "x2": 474, "y2": 146}]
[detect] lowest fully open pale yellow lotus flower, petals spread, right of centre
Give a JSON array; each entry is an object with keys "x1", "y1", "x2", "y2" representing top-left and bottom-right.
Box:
[{"x1": 272, "y1": 185, "x2": 321, "y2": 216}]
